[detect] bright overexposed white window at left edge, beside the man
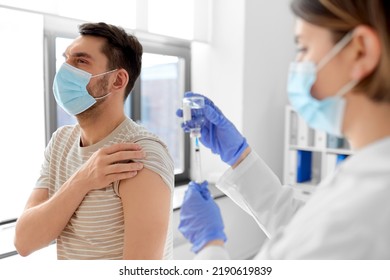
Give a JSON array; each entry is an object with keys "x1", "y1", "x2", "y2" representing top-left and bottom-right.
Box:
[{"x1": 0, "y1": 8, "x2": 45, "y2": 224}]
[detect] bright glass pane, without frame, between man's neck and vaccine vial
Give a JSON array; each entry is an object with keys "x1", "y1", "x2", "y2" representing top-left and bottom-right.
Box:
[{"x1": 140, "y1": 53, "x2": 185, "y2": 177}]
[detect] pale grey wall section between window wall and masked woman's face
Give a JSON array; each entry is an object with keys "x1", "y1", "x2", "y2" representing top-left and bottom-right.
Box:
[{"x1": 242, "y1": 0, "x2": 294, "y2": 179}]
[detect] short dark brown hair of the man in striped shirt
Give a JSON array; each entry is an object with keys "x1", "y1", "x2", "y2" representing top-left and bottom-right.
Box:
[{"x1": 79, "y1": 22, "x2": 143, "y2": 100}]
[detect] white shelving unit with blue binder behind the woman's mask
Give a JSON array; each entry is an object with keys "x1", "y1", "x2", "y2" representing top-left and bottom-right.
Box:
[{"x1": 283, "y1": 106, "x2": 354, "y2": 200}]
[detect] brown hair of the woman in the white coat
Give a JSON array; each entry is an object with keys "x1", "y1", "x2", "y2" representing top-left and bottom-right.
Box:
[{"x1": 291, "y1": 0, "x2": 390, "y2": 102}]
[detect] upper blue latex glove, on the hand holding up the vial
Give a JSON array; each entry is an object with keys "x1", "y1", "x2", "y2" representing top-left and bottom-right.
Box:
[{"x1": 176, "y1": 92, "x2": 248, "y2": 165}]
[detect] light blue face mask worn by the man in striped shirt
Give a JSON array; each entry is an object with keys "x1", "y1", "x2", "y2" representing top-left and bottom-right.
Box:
[{"x1": 53, "y1": 63, "x2": 116, "y2": 116}]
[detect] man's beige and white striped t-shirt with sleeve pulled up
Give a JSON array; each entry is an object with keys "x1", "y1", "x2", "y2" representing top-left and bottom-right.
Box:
[{"x1": 36, "y1": 118, "x2": 174, "y2": 259}]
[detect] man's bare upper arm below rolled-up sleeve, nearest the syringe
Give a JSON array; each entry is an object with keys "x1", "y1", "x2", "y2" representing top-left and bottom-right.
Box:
[{"x1": 119, "y1": 168, "x2": 172, "y2": 259}]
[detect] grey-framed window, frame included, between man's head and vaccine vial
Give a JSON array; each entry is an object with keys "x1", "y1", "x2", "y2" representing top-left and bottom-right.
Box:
[{"x1": 135, "y1": 44, "x2": 191, "y2": 180}]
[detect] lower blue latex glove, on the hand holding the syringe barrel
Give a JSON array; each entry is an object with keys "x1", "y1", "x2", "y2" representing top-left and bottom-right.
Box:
[{"x1": 179, "y1": 181, "x2": 227, "y2": 253}]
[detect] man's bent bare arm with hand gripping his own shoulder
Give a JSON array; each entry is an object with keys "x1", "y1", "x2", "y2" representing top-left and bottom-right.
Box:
[{"x1": 14, "y1": 143, "x2": 145, "y2": 256}]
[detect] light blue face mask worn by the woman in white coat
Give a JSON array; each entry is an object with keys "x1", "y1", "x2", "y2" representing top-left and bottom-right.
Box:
[{"x1": 287, "y1": 32, "x2": 358, "y2": 137}]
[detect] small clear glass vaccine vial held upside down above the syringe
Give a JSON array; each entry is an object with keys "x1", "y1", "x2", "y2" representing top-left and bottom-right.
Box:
[{"x1": 183, "y1": 96, "x2": 204, "y2": 138}]
